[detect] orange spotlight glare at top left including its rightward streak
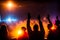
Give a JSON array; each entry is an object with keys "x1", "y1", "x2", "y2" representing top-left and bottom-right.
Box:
[{"x1": 2, "y1": 0, "x2": 22, "y2": 11}]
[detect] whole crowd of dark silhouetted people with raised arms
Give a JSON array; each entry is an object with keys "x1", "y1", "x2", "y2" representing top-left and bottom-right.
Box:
[{"x1": 0, "y1": 13, "x2": 60, "y2": 40}]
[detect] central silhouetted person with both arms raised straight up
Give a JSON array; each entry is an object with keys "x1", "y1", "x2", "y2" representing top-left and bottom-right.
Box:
[{"x1": 27, "y1": 13, "x2": 44, "y2": 40}]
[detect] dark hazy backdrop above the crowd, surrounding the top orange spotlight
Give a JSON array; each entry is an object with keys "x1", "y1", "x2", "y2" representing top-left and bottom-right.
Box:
[{"x1": 0, "y1": 0, "x2": 60, "y2": 19}]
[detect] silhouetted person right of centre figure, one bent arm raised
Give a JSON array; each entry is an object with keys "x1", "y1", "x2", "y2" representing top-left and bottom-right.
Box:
[{"x1": 47, "y1": 15, "x2": 56, "y2": 40}]
